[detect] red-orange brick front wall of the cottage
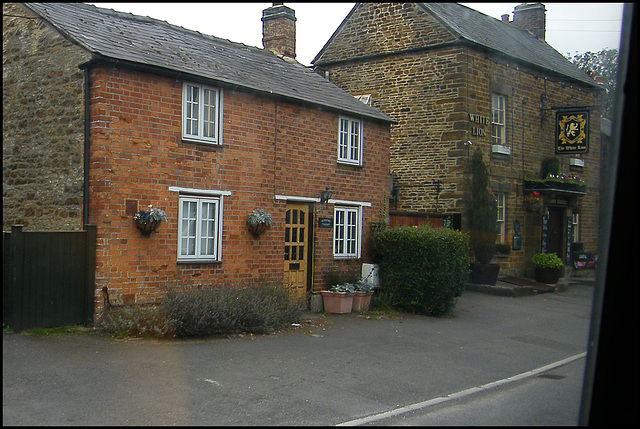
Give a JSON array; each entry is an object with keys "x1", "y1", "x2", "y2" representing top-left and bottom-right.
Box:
[{"x1": 89, "y1": 66, "x2": 389, "y2": 308}]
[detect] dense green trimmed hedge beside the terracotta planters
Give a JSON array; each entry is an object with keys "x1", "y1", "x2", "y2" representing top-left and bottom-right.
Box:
[{"x1": 371, "y1": 226, "x2": 469, "y2": 316}]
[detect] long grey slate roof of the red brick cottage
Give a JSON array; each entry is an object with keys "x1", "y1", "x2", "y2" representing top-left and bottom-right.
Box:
[{"x1": 24, "y1": 3, "x2": 394, "y2": 122}]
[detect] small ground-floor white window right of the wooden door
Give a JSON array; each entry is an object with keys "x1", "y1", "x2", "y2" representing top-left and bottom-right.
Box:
[{"x1": 333, "y1": 207, "x2": 362, "y2": 258}]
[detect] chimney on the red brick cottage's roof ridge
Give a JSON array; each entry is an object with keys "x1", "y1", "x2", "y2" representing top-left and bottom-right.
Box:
[{"x1": 262, "y1": 3, "x2": 296, "y2": 59}]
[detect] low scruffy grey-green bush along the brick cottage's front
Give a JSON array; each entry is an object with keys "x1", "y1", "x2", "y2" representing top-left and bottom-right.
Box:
[{"x1": 100, "y1": 285, "x2": 302, "y2": 338}]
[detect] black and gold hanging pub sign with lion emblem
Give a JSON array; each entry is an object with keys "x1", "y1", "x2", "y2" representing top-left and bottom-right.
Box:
[{"x1": 556, "y1": 110, "x2": 589, "y2": 154}]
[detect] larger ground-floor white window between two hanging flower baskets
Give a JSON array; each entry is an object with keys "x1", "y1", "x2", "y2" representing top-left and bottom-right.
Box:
[{"x1": 178, "y1": 196, "x2": 222, "y2": 262}]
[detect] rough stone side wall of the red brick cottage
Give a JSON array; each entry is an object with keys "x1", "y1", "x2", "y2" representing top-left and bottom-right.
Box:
[{"x1": 2, "y1": 3, "x2": 88, "y2": 231}]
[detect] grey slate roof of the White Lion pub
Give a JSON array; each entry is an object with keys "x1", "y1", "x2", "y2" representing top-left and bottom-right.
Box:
[{"x1": 312, "y1": 3, "x2": 600, "y2": 88}]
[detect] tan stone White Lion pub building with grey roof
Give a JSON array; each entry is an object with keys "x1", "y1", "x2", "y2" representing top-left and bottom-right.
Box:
[{"x1": 313, "y1": 3, "x2": 604, "y2": 276}]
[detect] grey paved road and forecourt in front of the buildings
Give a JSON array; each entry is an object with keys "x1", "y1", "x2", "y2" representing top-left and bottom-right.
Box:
[{"x1": 2, "y1": 284, "x2": 593, "y2": 425}]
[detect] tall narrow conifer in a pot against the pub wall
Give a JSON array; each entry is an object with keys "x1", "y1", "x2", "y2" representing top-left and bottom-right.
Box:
[{"x1": 467, "y1": 149, "x2": 500, "y2": 285}]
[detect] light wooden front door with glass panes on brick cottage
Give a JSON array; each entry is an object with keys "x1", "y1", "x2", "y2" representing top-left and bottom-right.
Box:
[{"x1": 284, "y1": 204, "x2": 310, "y2": 299}]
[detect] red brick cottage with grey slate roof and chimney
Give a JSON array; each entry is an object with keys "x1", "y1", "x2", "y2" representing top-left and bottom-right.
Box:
[{"x1": 3, "y1": 3, "x2": 393, "y2": 310}]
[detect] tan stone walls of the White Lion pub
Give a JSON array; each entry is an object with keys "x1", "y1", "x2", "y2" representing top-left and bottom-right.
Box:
[{"x1": 317, "y1": 3, "x2": 603, "y2": 275}]
